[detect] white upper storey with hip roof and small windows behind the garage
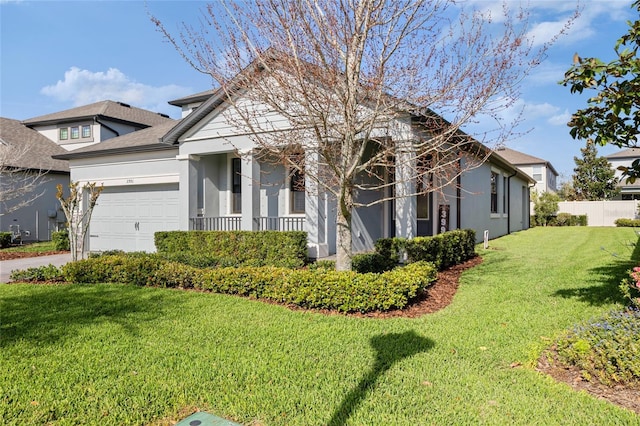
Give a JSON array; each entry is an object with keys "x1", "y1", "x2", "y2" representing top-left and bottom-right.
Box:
[{"x1": 22, "y1": 101, "x2": 171, "y2": 151}]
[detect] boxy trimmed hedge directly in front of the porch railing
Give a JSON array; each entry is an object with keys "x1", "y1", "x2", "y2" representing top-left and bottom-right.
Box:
[{"x1": 155, "y1": 231, "x2": 307, "y2": 268}]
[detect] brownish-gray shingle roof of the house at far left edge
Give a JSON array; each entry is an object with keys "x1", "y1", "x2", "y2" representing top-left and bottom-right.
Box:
[{"x1": 0, "y1": 117, "x2": 69, "y2": 173}]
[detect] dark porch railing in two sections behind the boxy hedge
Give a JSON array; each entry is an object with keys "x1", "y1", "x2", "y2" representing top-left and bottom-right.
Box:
[{"x1": 189, "y1": 216, "x2": 305, "y2": 231}]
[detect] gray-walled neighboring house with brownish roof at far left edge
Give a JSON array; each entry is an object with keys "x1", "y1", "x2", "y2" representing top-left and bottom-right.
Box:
[{"x1": 0, "y1": 118, "x2": 69, "y2": 241}]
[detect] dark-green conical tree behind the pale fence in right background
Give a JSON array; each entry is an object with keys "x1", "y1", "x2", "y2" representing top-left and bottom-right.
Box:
[{"x1": 573, "y1": 140, "x2": 620, "y2": 201}]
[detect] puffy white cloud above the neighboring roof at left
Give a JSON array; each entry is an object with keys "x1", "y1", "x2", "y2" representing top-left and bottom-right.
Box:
[{"x1": 41, "y1": 67, "x2": 191, "y2": 115}]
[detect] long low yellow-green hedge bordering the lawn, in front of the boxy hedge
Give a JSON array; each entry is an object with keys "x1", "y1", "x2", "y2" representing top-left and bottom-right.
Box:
[{"x1": 62, "y1": 254, "x2": 437, "y2": 312}]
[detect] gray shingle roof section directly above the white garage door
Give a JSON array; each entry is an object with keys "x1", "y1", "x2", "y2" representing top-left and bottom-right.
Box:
[{"x1": 50, "y1": 120, "x2": 179, "y2": 160}]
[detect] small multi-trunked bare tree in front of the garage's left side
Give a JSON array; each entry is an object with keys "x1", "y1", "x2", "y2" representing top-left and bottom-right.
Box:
[{"x1": 56, "y1": 181, "x2": 104, "y2": 262}]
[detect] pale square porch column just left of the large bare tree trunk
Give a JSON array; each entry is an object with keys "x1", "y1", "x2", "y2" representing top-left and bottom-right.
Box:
[{"x1": 304, "y1": 151, "x2": 329, "y2": 259}]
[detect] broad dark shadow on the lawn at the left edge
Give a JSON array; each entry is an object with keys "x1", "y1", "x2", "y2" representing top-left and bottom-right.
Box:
[{"x1": 0, "y1": 285, "x2": 175, "y2": 348}]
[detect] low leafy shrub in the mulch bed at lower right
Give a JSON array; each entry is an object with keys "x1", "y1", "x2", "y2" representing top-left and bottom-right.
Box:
[{"x1": 556, "y1": 309, "x2": 640, "y2": 387}]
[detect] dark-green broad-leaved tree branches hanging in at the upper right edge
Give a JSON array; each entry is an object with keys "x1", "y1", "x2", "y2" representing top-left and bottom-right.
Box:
[{"x1": 561, "y1": 0, "x2": 640, "y2": 183}]
